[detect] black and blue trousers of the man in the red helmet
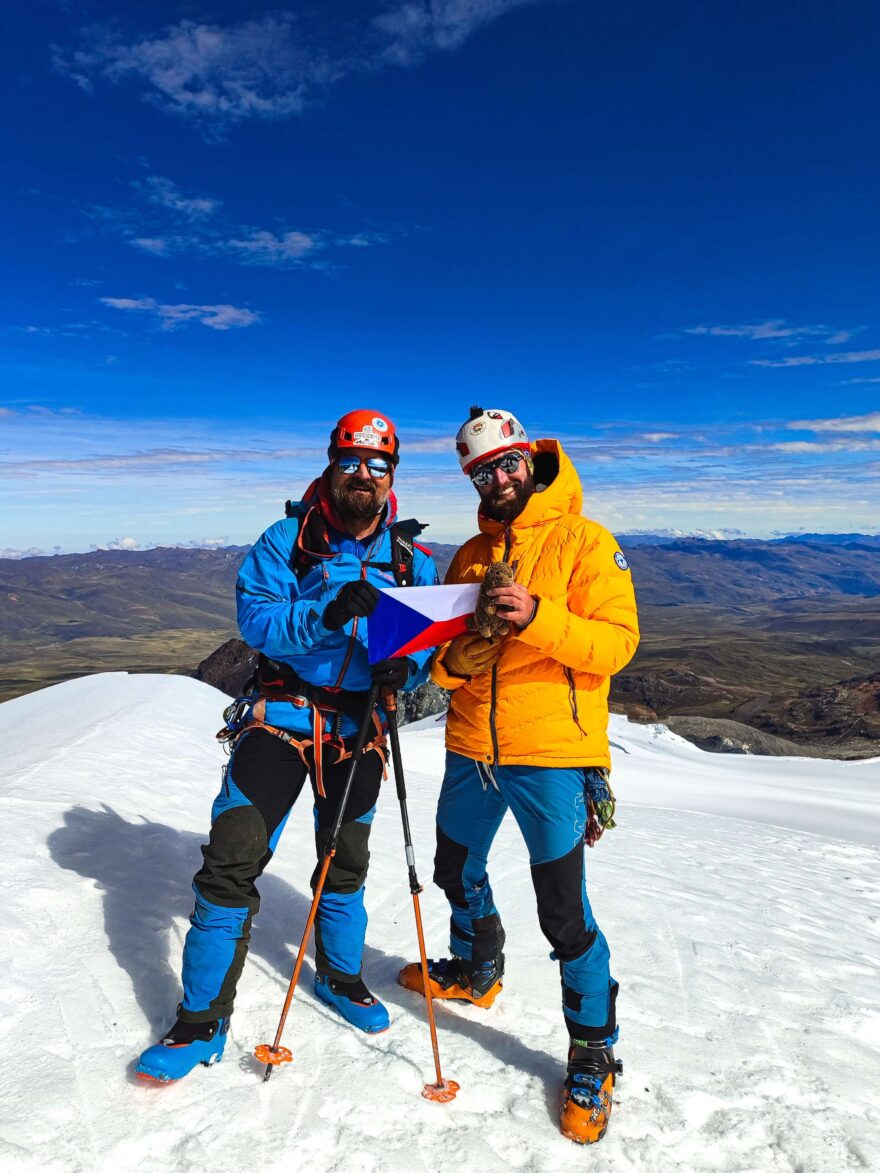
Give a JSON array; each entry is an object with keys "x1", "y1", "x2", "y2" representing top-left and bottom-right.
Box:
[{"x1": 178, "y1": 730, "x2": 385, "y2": 1022}]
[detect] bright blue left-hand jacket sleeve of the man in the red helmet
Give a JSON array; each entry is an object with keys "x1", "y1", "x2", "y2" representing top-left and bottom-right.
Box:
[{"x1": 236, "y1": 520, "x2": 330, "y2": 660}]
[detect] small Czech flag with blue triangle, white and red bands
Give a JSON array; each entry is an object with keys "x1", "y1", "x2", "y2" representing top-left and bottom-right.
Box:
[{"x1": 367, "y1": 583, "x2": 480, "y2": 664}]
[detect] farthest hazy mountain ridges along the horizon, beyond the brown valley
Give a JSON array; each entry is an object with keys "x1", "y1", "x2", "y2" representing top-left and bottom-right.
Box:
[{"x1": 0, "y1": 534, "x2": 880, "y2": 655}]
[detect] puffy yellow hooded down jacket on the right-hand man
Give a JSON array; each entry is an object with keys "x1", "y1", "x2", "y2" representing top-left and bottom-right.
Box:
[{"x1": 432, "y1": 440, "x2": 638, "y2": 767}]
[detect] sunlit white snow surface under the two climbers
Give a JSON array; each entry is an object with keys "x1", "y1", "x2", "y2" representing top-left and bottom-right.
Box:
[{"x1": 0, "y1": 673, "x2": 880, "y2": 1173}]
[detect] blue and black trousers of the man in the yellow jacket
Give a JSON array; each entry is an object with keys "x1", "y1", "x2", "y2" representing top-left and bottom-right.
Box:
[{"x1": 434, "y1": 752, "x2": 617, "y2": 1039}]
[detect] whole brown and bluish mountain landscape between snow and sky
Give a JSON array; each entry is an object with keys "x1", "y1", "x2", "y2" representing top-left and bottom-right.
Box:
[{"x1": 0, "y1": 534, "x2": 880, "y2": 755}]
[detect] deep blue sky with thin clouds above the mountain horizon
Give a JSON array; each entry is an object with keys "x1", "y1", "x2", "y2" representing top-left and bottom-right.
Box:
[{"x1": 0, "y1": 0, "x2": 880, "y2": 556}]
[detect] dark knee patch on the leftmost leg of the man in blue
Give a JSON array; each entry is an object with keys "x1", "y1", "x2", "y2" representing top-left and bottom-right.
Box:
[{"x1": 194, "y1": 806, "x2": 269, "y2": 913}]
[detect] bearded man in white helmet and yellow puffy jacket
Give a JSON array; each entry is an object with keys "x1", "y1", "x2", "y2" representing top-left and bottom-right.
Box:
[{"x1": 399, "y1": 407, "x2": 638, "y2": 1144}]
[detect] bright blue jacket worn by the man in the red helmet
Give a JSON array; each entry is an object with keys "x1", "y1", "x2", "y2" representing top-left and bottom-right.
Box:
[{"x1": 236, "y1": 497, "x2": 438, "y2": 737}]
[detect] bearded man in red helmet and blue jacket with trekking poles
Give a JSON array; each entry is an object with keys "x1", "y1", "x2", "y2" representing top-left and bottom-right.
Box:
[{"x1": 137, "y1": 411, "x2": 438, "y2": 1082}]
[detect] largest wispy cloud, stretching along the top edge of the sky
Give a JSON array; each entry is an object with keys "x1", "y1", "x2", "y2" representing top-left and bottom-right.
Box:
[{"x1": 53, "y1": 0, "x2": 537, "y2": 138}]
